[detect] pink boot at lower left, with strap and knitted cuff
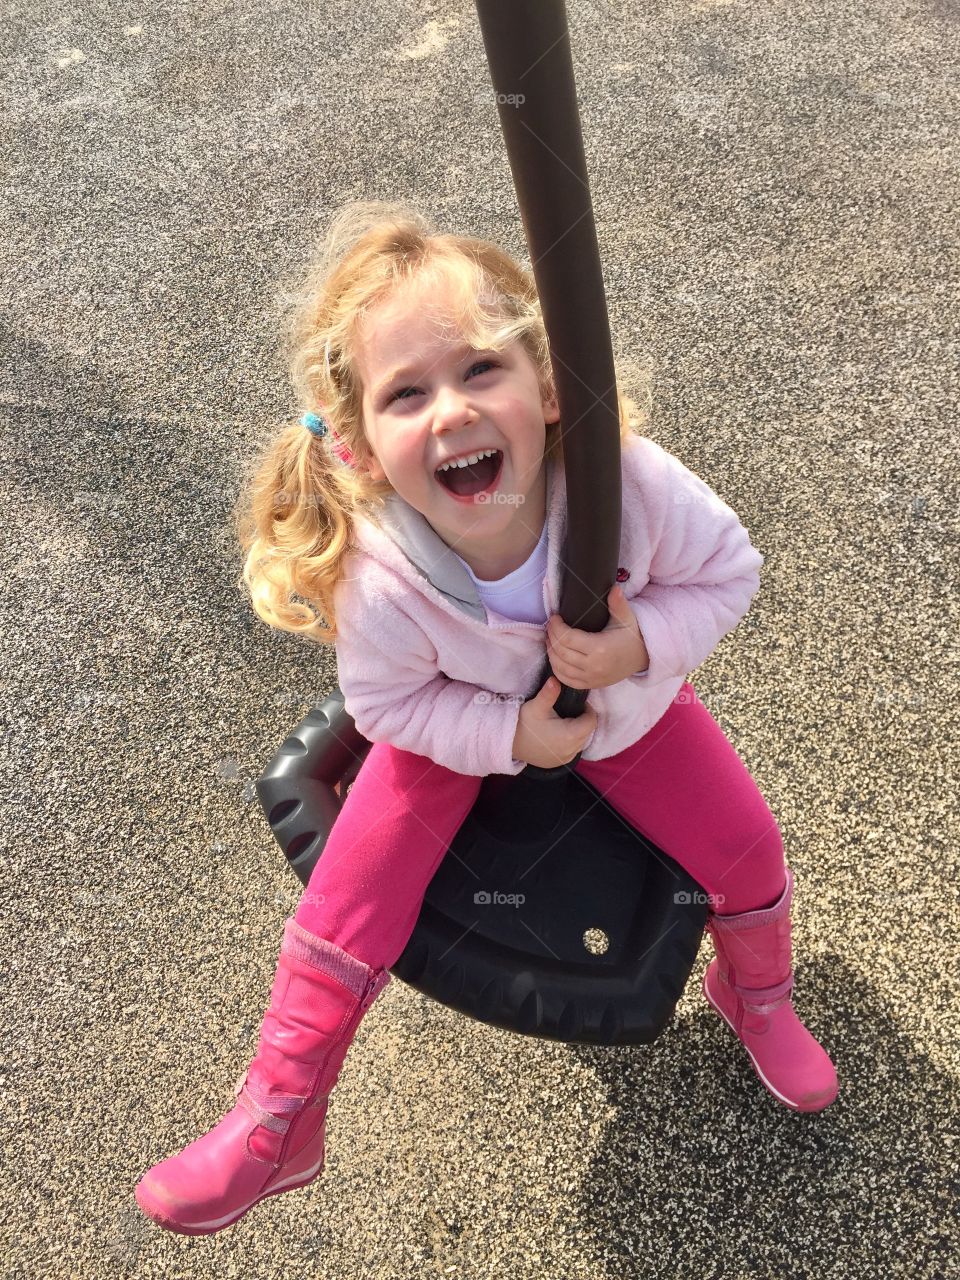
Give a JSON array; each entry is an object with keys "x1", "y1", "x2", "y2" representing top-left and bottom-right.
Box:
[{"x1": 136, "y1": 919, "x2": 390, "y2": 1235}]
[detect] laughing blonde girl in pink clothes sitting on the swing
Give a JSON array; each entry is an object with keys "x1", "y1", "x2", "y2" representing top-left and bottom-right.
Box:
[{"x1": 136, "y1": 202, "x2": 837, "y2": 1234}]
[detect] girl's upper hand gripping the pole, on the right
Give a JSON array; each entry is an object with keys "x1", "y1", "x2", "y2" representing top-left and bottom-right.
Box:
[{"x1": 547, "y1": 582, "x2": 650, "y2": 689}]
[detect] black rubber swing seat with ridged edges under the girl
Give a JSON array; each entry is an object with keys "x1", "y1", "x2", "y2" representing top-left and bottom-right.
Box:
[{"x1": 256, "y1": 689, "x2": 707, "y2": 1044}]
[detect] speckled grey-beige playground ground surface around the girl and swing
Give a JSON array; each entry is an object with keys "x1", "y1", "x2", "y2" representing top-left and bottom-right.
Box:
[{"x1": 0, "y1": 0, "x2": 960, "y2": 1280}]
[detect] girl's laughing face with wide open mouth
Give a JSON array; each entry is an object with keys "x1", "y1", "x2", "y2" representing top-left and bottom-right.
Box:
[{"x1": 358, "y1": 293, "x2": 559, "y2": 566}]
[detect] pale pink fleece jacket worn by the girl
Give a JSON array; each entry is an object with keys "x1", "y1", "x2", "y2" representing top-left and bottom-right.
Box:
[{"x1": 334, "y1": 435, "x2": 763, "y2": 777}]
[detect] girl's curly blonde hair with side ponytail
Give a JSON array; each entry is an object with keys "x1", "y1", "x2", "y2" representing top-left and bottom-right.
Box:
[{"x1": 233, "y1": 201, "x2": 648, "y2": 644}]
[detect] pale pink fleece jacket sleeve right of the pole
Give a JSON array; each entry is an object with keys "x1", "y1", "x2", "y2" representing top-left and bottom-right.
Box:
[{"x1": 628, "y1": 440, "x2": 763, "y2": 684}]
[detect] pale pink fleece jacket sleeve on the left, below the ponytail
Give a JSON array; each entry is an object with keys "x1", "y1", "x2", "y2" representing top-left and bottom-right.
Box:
[{"x1": 335, "y1": 559, "x2": 525, "y2": 777}]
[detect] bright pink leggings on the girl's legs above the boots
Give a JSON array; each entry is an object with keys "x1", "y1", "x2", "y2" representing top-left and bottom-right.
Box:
[{"x1": 296, "y1": 681, "x2": 786, "y2": 969}]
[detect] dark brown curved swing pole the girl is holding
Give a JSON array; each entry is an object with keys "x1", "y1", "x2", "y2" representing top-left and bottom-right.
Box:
[{"x1": 475, "y1": 0, "x2": 622, "y2": 840}]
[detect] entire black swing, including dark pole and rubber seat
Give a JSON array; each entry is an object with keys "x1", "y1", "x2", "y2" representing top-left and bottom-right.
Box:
[{"x1": 256, "y1": 0, "x2": 707, "y2": 1044}]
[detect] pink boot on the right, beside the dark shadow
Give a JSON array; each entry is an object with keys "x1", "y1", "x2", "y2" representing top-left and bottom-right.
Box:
[{"x1": 703, "y1": 867, "x2": 837, "y2": 1111}]
